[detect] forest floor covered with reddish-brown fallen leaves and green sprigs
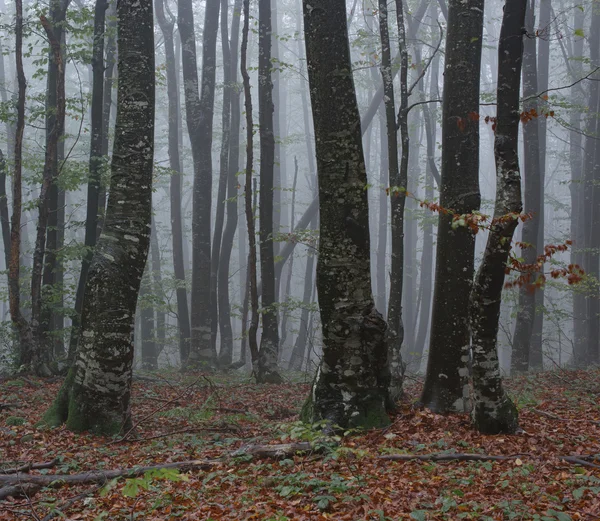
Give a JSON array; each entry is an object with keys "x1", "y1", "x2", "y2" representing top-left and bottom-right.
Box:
[{"x1": 0, "y1": 370, "x2": 600, "y2": 521}]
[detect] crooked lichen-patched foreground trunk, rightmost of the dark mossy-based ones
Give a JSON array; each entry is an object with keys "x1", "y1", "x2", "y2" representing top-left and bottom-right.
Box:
[{"x1": 469, "y1": 0, "x2": 527, "y2": 434}]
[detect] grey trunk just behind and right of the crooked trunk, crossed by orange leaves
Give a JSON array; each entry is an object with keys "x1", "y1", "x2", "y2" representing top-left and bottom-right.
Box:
[{"x1": 511, "y1": 0, "x2": 542, "y2": 372}]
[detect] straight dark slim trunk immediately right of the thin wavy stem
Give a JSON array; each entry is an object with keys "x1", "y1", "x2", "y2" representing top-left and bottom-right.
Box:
[{"x1": 256, "y1": 0, "x2": 282, "y2": 383}]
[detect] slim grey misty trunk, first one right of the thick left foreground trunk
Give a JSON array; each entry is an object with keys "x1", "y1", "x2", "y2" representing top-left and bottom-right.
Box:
[{"x1": 155, "y1": 0, "x2": 190, "y2": 365}]
